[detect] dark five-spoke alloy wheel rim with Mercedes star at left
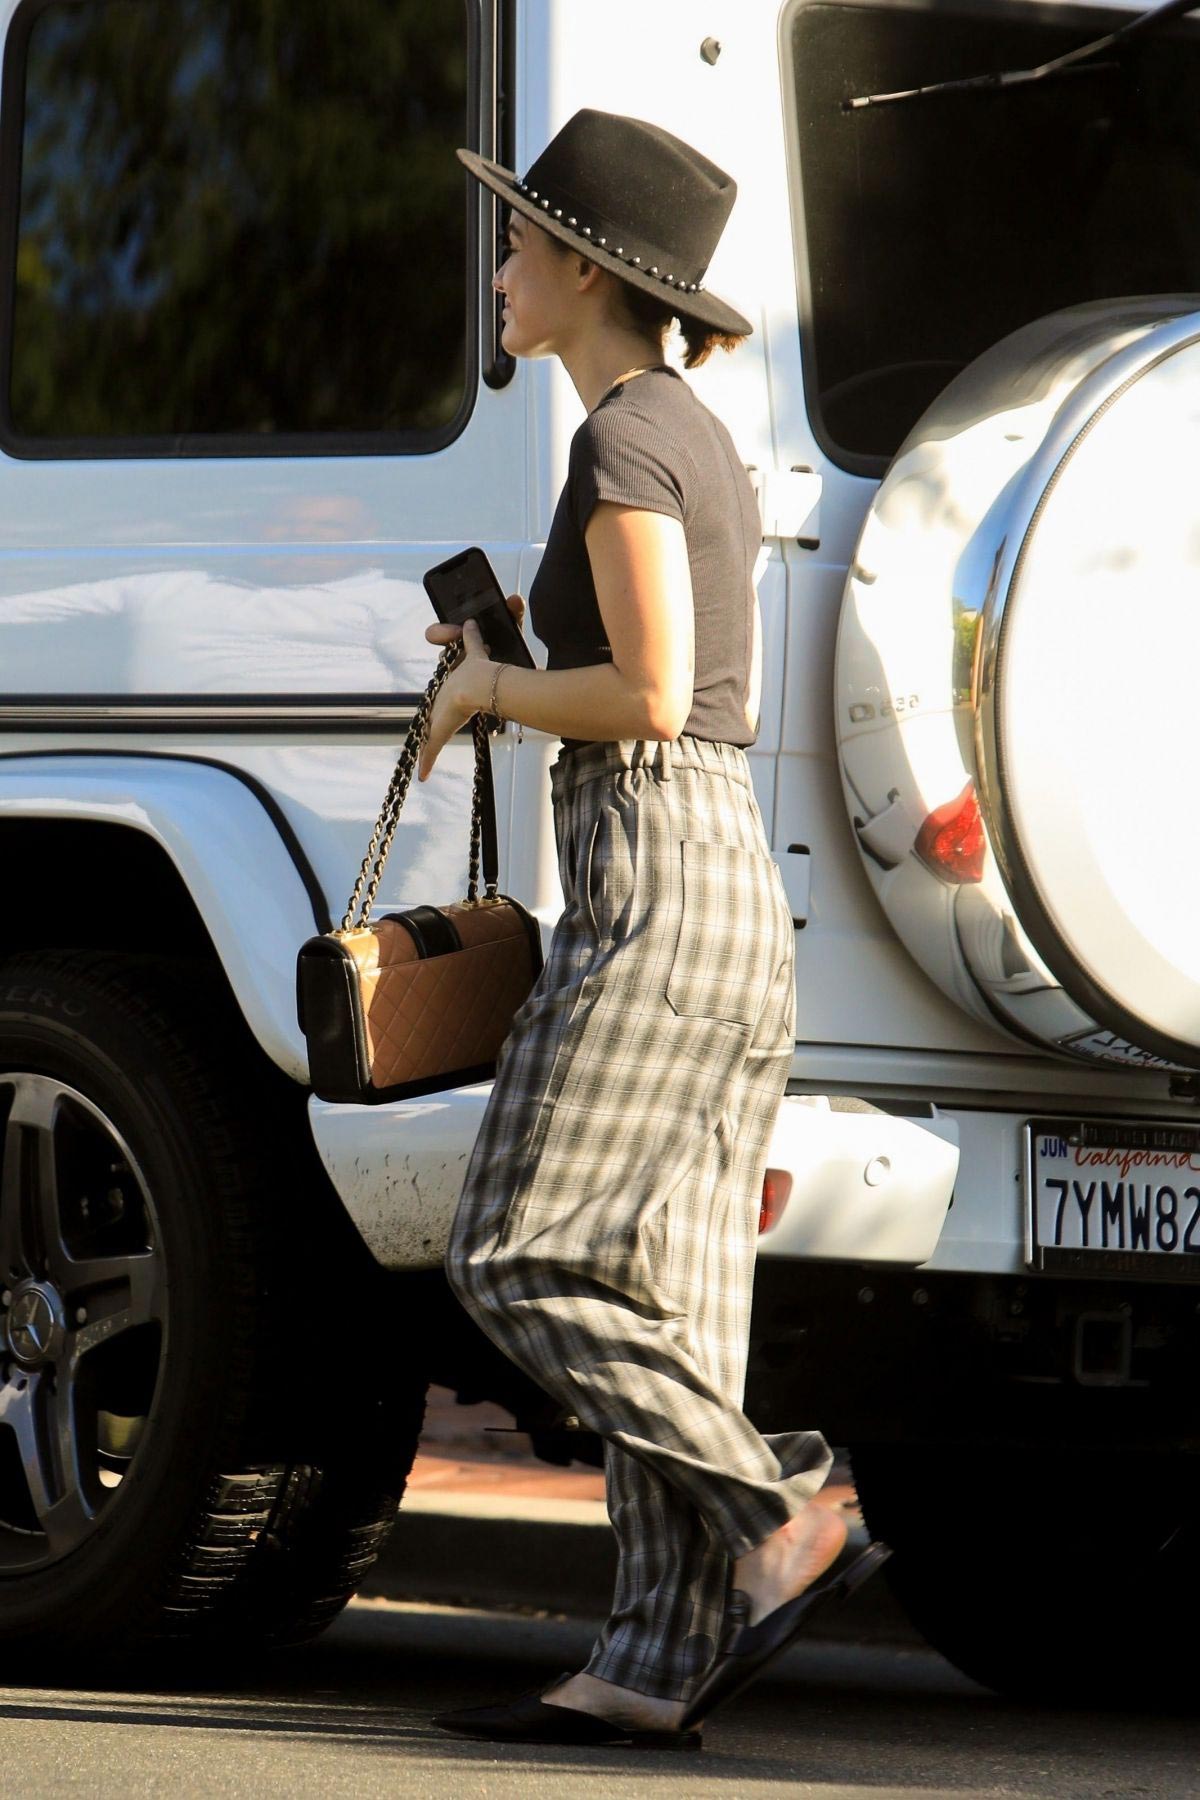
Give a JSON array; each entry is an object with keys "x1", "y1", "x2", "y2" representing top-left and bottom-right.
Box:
[{"x1": 0, "y1": 1071, "x2": 167, "y2": 1580}]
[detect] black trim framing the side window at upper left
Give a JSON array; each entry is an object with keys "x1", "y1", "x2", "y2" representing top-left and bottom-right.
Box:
[{"x1": 0, "y1": 0, "x2": 492, "y2": 463}]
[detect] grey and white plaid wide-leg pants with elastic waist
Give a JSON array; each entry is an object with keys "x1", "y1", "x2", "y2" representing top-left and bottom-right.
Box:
[{"x1": 446, "y1": 738, "x2": 829, "y2": 1699}]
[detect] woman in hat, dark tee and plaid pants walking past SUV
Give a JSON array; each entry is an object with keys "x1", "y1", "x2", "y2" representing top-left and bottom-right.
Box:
[{"x1": 419, "y1": 112, "x2": 878, "y2": 1748}]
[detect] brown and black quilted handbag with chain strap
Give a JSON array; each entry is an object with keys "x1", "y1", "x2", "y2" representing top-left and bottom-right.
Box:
[{"x1": 297, "y1": 644, "x2": 542, "y2": 1103}]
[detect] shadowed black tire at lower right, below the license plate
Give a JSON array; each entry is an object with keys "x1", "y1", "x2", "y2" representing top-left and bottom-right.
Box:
[{"x1": 853, "y1": 1445, "x2": 1200, "y2": 1710}]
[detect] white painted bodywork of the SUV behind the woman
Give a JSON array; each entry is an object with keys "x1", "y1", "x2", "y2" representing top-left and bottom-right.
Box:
[{"x1": 0, "y1": 0, "x2": 1187, "y2": 1271}]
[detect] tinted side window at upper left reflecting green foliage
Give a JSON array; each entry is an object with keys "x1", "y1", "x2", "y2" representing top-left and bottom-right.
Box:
[{"x1": 9, "y1": 0, "x2": 468, "y2": 437}]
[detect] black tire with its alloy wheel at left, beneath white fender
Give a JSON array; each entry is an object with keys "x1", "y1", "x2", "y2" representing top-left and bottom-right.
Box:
[{"x1": 0, "y1": 952, "x2": 426, "y2": 1656}]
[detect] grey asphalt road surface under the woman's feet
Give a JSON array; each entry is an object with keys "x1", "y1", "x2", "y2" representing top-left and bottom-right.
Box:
[{"x1": 0, "y1": 1600, "x2": 1200, "y2": 1800}]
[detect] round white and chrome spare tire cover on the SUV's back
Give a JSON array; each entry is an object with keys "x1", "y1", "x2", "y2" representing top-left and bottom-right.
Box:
[{"x1": 837, "y1": 295, "x2": 1200, "y2": 1067}]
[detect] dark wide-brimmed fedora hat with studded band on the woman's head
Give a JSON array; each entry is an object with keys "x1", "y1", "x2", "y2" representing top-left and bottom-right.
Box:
[{"x1": 459, "y1": 108, "x2": 754, "y2": 333}]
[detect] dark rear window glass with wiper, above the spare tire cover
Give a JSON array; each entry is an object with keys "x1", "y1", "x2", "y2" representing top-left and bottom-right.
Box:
[{"x1": 790, "y1": 4, "x2": 1200, "y2": 470}]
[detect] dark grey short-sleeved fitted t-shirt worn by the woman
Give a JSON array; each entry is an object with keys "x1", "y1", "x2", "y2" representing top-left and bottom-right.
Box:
[{"x1": 529, "y1": 369, "x2": 763, "y2": 747}]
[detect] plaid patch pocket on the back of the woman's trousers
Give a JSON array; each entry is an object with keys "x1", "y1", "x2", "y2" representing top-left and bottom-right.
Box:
[{"x1": 666, "y1": 839, "x2": 783, "y2": 1026}]
